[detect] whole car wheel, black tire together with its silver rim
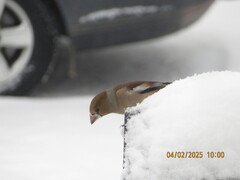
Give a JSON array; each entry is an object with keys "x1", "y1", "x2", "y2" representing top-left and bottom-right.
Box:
[{"x1": 0, "y1": 0, "x2": 60, "y2": 95}]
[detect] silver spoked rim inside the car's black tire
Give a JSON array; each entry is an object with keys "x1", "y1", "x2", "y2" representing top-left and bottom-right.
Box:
[{"x1": 0, "y1": 0, "x2": 34, "y2": 91}]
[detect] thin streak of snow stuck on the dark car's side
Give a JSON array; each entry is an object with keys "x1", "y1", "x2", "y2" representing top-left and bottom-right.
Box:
[{"x1": 79, "y1": 5, "x2": 172, "y2": 23}]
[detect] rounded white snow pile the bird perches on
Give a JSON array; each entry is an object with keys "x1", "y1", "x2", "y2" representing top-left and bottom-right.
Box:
[{"x1": 123, "y1": 72, "x2": 240, "y2": 180}]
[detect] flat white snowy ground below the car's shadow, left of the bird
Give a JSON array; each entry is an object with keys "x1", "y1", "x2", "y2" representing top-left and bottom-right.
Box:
[{"x1": 0, "y1": 97, "x2": 123, "y2": 180}]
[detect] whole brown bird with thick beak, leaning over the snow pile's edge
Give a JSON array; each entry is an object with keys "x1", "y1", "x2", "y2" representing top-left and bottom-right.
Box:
[{"x1": 89, "y1": 81, "x2": 171, "y2": 124}]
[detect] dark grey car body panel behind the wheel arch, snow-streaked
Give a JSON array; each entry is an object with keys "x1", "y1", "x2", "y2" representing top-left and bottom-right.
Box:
[{"x1": 55, "y1": 0, "x2": 213, "y2": 49}]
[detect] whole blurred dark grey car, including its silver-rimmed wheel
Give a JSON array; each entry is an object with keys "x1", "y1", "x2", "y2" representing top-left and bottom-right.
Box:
[{"x1": 0, "y1": 0, "x2": 213, "y2": 95}]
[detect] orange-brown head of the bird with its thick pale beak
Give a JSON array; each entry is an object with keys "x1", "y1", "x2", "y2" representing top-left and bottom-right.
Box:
[{"x1": 89, "y1": 91, "x2": 111, "y2": 124}]
